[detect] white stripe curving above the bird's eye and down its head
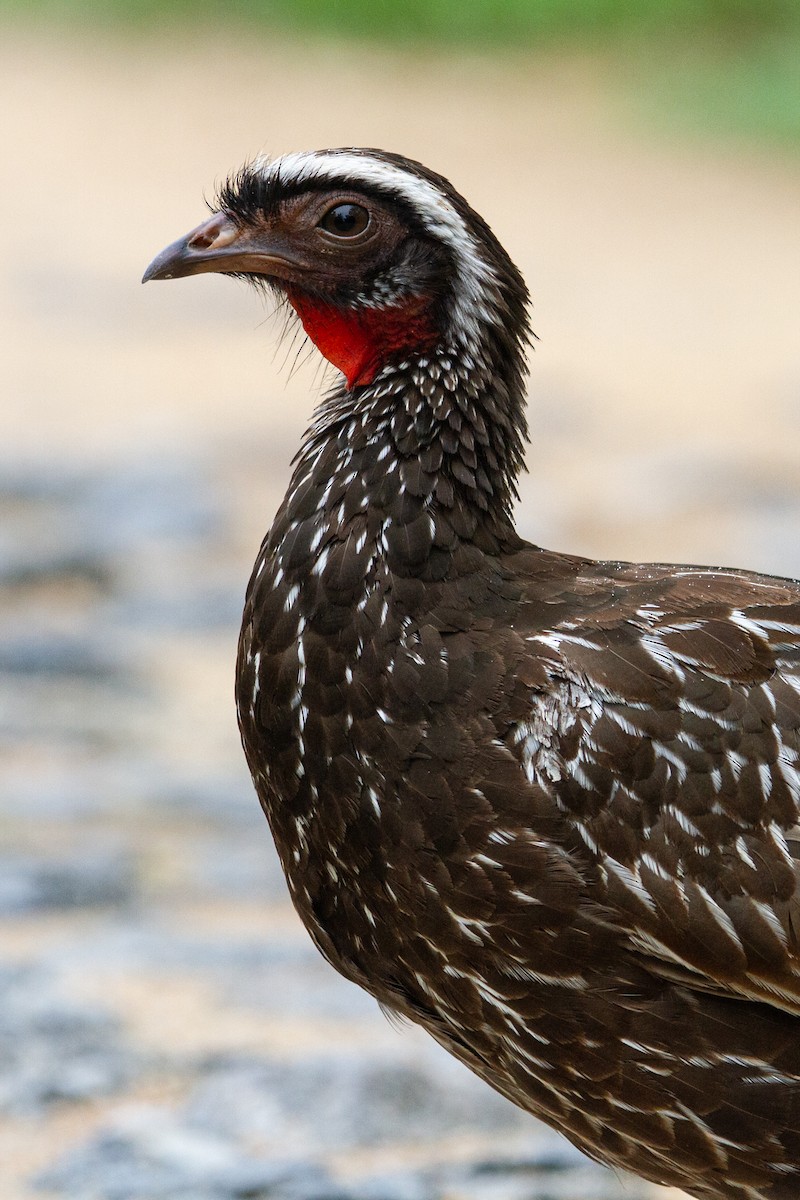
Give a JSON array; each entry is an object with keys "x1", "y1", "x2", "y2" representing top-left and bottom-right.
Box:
[{"x1": 253, "y1": 150, "x2": 499, "y2": 341}]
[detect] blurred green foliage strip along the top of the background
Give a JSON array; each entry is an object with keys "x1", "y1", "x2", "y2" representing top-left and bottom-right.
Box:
[{"x1": 0, "y1": 0, "x2": 800, "y2": 150}]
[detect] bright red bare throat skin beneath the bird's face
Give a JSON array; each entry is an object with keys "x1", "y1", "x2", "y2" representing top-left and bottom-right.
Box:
[{"x1": 288, "y1": 288, "x2": 437, "y2": 388}]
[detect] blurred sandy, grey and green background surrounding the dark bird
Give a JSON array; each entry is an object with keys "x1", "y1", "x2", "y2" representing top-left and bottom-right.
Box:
[{"x1": 0, "y1": 7, "x2": 800, "y2": 1200}]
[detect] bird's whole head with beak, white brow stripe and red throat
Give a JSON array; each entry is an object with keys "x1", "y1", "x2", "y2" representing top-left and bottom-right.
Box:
[{"x1": 143, "y1": 149, "x2": 528, "y2": 389}]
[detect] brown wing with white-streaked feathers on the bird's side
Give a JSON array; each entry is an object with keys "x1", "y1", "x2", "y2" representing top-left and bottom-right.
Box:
[{"x1": 505, "y1": 552, "x2": 800, "y2": 1013}]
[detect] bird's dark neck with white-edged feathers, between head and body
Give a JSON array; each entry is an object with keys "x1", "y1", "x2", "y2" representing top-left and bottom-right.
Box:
[{"x1": 285, "y1": 341, "x2": 527, "y2": 566}]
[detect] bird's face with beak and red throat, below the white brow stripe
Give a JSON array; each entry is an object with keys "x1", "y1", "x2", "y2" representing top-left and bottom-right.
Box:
[{"x1": 143, "y1": 188, "x2": 444, "y2": 388}]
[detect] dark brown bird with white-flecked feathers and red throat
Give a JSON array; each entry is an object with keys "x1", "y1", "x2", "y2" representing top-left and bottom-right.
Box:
[{"x1": 145, "y1": 148, "x2": 800, "y2": 1200}]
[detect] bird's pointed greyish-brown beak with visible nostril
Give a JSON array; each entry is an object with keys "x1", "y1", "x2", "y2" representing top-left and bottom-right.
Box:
[{"x1": 142, "y1": 212, "x2": 294, "y2": 283}]
